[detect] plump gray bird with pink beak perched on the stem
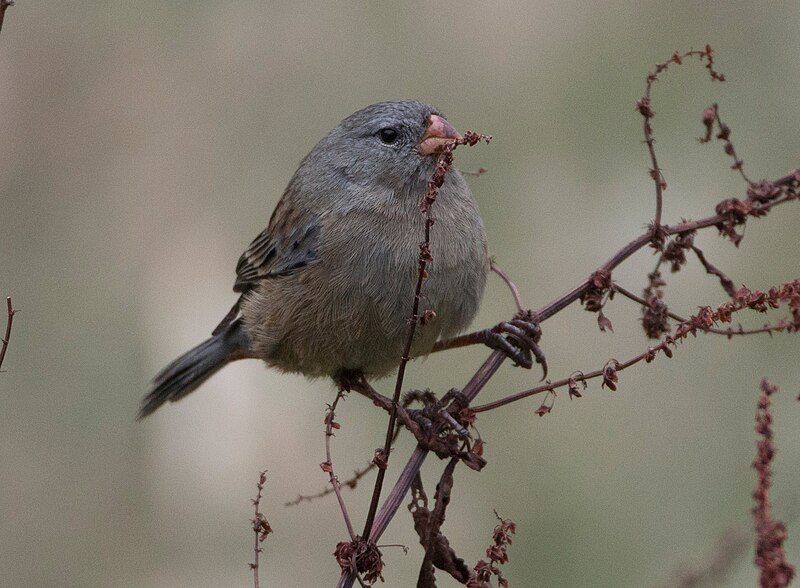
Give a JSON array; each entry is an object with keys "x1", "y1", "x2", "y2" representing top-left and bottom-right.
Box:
[{"x1": 139, "y1": 100, "x2": 489, "y2": 418}]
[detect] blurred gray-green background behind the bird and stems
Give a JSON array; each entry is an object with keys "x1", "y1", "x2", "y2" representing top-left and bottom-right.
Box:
[{"x1": 0, "y1": 0, "x2": 800, "y2": 587}]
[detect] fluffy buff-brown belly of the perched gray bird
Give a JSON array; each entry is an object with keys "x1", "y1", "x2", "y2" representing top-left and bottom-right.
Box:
[{"x1": 242, "y1": 240, "x2": 485, "y2": 377}]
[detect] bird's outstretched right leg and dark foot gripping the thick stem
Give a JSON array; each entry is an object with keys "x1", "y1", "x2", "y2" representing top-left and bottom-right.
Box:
[{"x1": 431, "y1": 310, "x2": 547, "y2": 379}]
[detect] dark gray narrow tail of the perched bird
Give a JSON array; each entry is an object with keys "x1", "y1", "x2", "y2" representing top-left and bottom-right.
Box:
[{"x1": 138, "y1": 319, "x2": 251, "y2": 419}]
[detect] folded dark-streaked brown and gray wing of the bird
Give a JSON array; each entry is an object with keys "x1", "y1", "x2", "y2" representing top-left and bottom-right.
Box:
[{"x1": 213, "y1": 202, "x2": 321, "y2": 335}]
